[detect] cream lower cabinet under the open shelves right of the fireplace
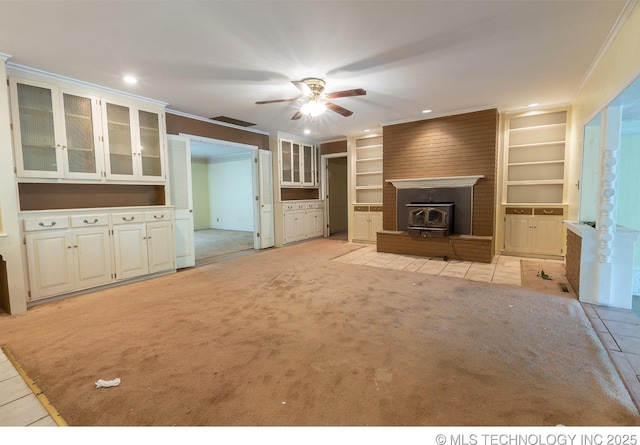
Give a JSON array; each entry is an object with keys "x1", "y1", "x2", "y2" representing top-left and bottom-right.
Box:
[{"x1": 504, "y1": 207, "x2": 564, "y2": 256}]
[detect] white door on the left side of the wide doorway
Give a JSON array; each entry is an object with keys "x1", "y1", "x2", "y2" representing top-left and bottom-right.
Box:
[{"x1": 167, "y1": 135, "x2": 196, "y2": 269}]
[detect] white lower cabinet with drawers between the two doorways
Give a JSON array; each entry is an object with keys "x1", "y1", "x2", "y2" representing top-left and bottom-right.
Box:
[{"x1": 282, "y1": 201, "x2": 324, "y2": 244}]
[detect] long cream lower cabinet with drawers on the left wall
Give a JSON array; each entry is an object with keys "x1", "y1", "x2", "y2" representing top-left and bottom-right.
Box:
[{"x1": 23, "y1": 209, "x2": 175, "y2": 300}]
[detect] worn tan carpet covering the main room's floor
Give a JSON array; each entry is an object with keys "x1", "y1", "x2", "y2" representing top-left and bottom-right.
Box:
[{"x1": 0, "y1": 239, "x2": 640, "y2": 426}]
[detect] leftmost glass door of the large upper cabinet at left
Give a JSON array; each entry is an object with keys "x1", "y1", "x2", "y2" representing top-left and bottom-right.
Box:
[{"x1": 14, "y1": 82, "x2": 63, "y2": 177}]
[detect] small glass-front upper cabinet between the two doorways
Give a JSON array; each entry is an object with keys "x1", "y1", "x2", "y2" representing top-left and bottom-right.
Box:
[{"x1": 278, "y1": 138, "x2": 318, "y2": 187}]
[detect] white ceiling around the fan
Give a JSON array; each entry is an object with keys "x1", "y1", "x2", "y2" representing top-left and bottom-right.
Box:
[{"x1": 0, "y1": 0, "x2": 626, "y2": 140}]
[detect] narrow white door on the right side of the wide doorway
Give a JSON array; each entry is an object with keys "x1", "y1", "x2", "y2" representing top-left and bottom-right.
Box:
[{"x1": 256, "y1": 150, "x2": 275, "y2": 249}]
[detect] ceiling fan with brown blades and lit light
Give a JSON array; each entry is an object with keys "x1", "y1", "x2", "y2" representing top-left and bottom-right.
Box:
[{"x1": 256, "y1": 77, "x2": 367, "y2": 120}]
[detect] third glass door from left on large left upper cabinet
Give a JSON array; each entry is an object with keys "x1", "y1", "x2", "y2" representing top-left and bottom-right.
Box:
[{"x1": 106, "y1": 103, "x2": 134, "y2": 176}]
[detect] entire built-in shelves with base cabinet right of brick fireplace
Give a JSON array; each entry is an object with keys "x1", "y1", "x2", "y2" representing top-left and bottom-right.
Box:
[{"x1": 501, "y1": 109, "x2": 568, "y2": 257}]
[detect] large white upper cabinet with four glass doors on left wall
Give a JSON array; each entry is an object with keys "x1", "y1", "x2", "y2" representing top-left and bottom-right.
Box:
[{"x1": 9, "y1": 76, "x2": 165, "y2": 182}]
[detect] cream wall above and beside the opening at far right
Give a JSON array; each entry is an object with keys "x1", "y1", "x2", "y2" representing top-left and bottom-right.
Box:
[{"x1": 568, "y1": 4, "x2": 640, "y2": 220}]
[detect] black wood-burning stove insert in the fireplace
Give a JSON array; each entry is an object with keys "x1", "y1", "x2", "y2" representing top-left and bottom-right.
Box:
[{"x1": 406, "y1": 202, "x2": 454, "y2": 237}]
